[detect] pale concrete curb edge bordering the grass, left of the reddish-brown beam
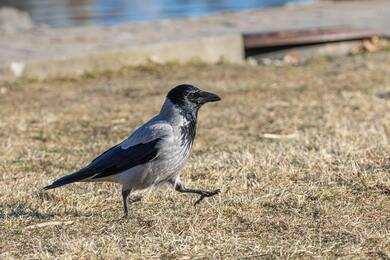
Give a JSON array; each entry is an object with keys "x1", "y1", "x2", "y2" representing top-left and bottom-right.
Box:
[{"x1": 0, "y1": 35, "x2": 244, "y2": 81}]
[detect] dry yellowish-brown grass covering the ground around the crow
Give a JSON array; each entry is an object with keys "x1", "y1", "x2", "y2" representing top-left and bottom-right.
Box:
[{"x1": 0, "y1": 52, "x2": 390, "y2": 259}]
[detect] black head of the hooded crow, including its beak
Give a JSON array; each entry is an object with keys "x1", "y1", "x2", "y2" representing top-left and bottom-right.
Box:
[{"x1": 167, "y1": 84, "x2": 221, "y2": 109}]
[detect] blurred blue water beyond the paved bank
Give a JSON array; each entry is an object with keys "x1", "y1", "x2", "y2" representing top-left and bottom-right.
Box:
[{"x1": 0, "y1": 0, "x2": 312, "y2": 27}]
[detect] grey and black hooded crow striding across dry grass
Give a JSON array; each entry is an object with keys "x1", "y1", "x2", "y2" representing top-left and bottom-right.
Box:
[{"x1": 44, "y1": 84, "x2": 221, "y2": 217}]
